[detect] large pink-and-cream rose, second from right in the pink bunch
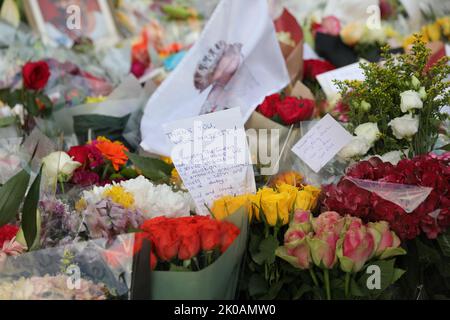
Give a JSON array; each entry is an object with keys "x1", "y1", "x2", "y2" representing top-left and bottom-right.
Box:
[{"x1": 337, "y1": 216, "x2": 375, "y2": 272}]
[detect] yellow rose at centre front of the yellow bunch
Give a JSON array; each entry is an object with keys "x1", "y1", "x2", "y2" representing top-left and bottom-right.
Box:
[{"x1": 261, "y1": 188, "x2": 290, "y2": 226}]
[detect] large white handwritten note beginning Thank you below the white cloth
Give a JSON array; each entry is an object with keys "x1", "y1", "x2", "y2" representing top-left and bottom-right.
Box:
[{"x1": 163, "y1": 108, "x2": 256, "y2": 215}]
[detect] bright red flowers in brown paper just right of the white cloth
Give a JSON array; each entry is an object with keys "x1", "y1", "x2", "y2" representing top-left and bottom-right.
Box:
[{"x1": 258, "y1": 93, "x2": 316, "y2": 125}]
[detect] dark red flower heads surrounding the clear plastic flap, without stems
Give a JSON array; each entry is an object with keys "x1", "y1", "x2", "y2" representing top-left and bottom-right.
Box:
[{"x1": 322, "y1": 153, "x2": 450, "y2": 239}]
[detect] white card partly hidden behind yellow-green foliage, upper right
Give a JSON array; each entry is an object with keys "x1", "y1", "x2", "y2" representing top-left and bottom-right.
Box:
[{"x1": 316, "y1": 62, "x2": 365, "y2": 98}]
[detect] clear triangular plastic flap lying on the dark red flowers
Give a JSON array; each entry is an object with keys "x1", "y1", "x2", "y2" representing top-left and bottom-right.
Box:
[{"x1": 345, "y1": 177, "x2": 433, "y2": 213}]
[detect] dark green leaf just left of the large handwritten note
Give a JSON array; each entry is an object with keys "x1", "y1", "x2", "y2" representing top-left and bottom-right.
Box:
[{"x1": 126, "y1": 152, "x2": 173, "y2": 180}]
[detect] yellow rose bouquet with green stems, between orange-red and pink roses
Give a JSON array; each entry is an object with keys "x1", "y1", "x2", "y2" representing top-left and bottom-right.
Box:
[{"x1": 211, "y1": 172, "x2": 320, "y2": 299}]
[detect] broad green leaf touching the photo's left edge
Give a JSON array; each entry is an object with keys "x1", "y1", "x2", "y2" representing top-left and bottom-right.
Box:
[{"x1": 0, "y1": 170, "x2": 30, "y2": 227}]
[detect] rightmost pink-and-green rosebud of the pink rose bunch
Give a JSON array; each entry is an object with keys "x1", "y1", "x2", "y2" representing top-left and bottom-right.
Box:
[{"x1": 367, "y1": 221, "x2": 406, "y2": 259}]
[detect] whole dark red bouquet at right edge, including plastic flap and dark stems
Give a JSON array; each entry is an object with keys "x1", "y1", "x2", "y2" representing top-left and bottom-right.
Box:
[{"x1": 322, "y1": 153, "x2": 450, "y2": 299}]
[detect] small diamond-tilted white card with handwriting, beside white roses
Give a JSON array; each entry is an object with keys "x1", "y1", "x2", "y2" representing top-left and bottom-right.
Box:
[{"x1": 292, "y1": 114, "x2": 352, "y2": 173}]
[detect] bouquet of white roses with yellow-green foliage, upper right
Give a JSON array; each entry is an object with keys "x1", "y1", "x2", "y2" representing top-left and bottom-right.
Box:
[{"x1": 337, "y1": 39, "x2": 450, "y2": 159}]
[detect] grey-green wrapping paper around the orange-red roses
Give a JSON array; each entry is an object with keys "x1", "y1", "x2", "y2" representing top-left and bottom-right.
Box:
[{"x1": 150, "y1": 208, "x2": 248, "y2": 300}]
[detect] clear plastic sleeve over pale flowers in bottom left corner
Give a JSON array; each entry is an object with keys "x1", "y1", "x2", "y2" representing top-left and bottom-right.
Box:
[{"x1": 0, "y1": 234, "x2": 134, "y2": 300}]
